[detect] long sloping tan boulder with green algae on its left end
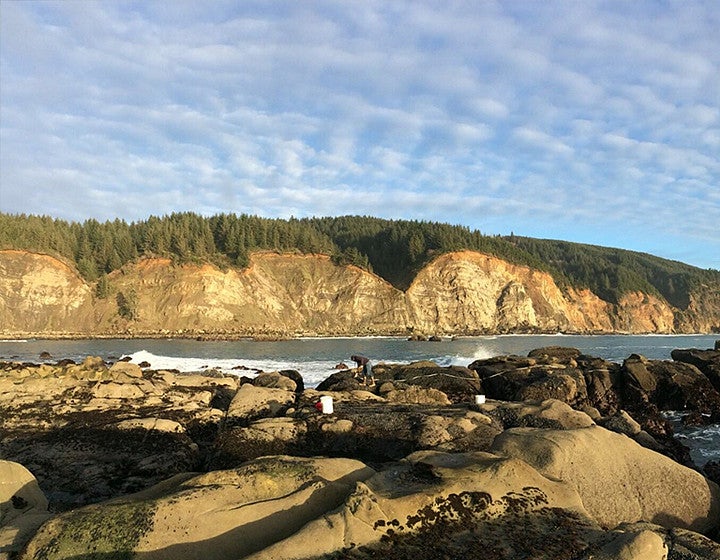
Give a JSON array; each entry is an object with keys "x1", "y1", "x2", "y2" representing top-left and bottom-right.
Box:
[{"x1": 20, "y1": 457, "x2": 374, "y2": 560}]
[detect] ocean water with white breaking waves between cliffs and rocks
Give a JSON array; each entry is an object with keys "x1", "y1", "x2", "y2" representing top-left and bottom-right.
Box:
[{"x1": 0, "y1": 335, "x2": 720, "y2": 465}]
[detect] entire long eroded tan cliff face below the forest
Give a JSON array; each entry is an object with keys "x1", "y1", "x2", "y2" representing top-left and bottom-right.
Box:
[{"x1": 0, "y1": 251, "x2": 720, "y2": 336}]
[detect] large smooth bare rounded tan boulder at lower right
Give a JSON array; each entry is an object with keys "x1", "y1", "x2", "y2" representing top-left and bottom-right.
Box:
[{"x1": 492, "y1": 426, "x2": 720, "y2": 533}]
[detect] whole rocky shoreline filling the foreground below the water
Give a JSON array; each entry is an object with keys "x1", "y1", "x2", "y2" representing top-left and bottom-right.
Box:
[{"x1": 0, "y1": 347, "x2": 720, "y2": 560}]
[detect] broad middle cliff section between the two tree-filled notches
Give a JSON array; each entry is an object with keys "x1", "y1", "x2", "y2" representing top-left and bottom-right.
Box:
[{"x1": 99, "y1": 253, "x2": 406, "y2": 334}]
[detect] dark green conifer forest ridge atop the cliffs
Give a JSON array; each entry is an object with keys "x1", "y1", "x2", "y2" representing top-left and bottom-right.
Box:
[{"x1": 0, "y1": 212, "x2": 720, "y2": 308}]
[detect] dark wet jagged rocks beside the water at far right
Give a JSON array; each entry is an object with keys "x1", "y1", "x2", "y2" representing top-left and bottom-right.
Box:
[{"x1": 469, "y1": 347, "x2": 720, "y2": 466}]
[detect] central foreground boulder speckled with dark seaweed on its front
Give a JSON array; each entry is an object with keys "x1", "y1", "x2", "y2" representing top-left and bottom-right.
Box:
[{"x1": 247, "y1": 452, "x2": 592, "y2": 560}]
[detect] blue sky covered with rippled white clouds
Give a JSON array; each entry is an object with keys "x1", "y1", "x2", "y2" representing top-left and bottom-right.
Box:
[{"x1": 0, "y1": 0, "x2": 720, "y2": 269}]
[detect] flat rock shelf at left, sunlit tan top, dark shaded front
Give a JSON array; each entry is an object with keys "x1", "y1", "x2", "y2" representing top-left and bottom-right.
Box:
[{"x1": 0, "y1": 358, "x2": 239, "y2": 511}]
